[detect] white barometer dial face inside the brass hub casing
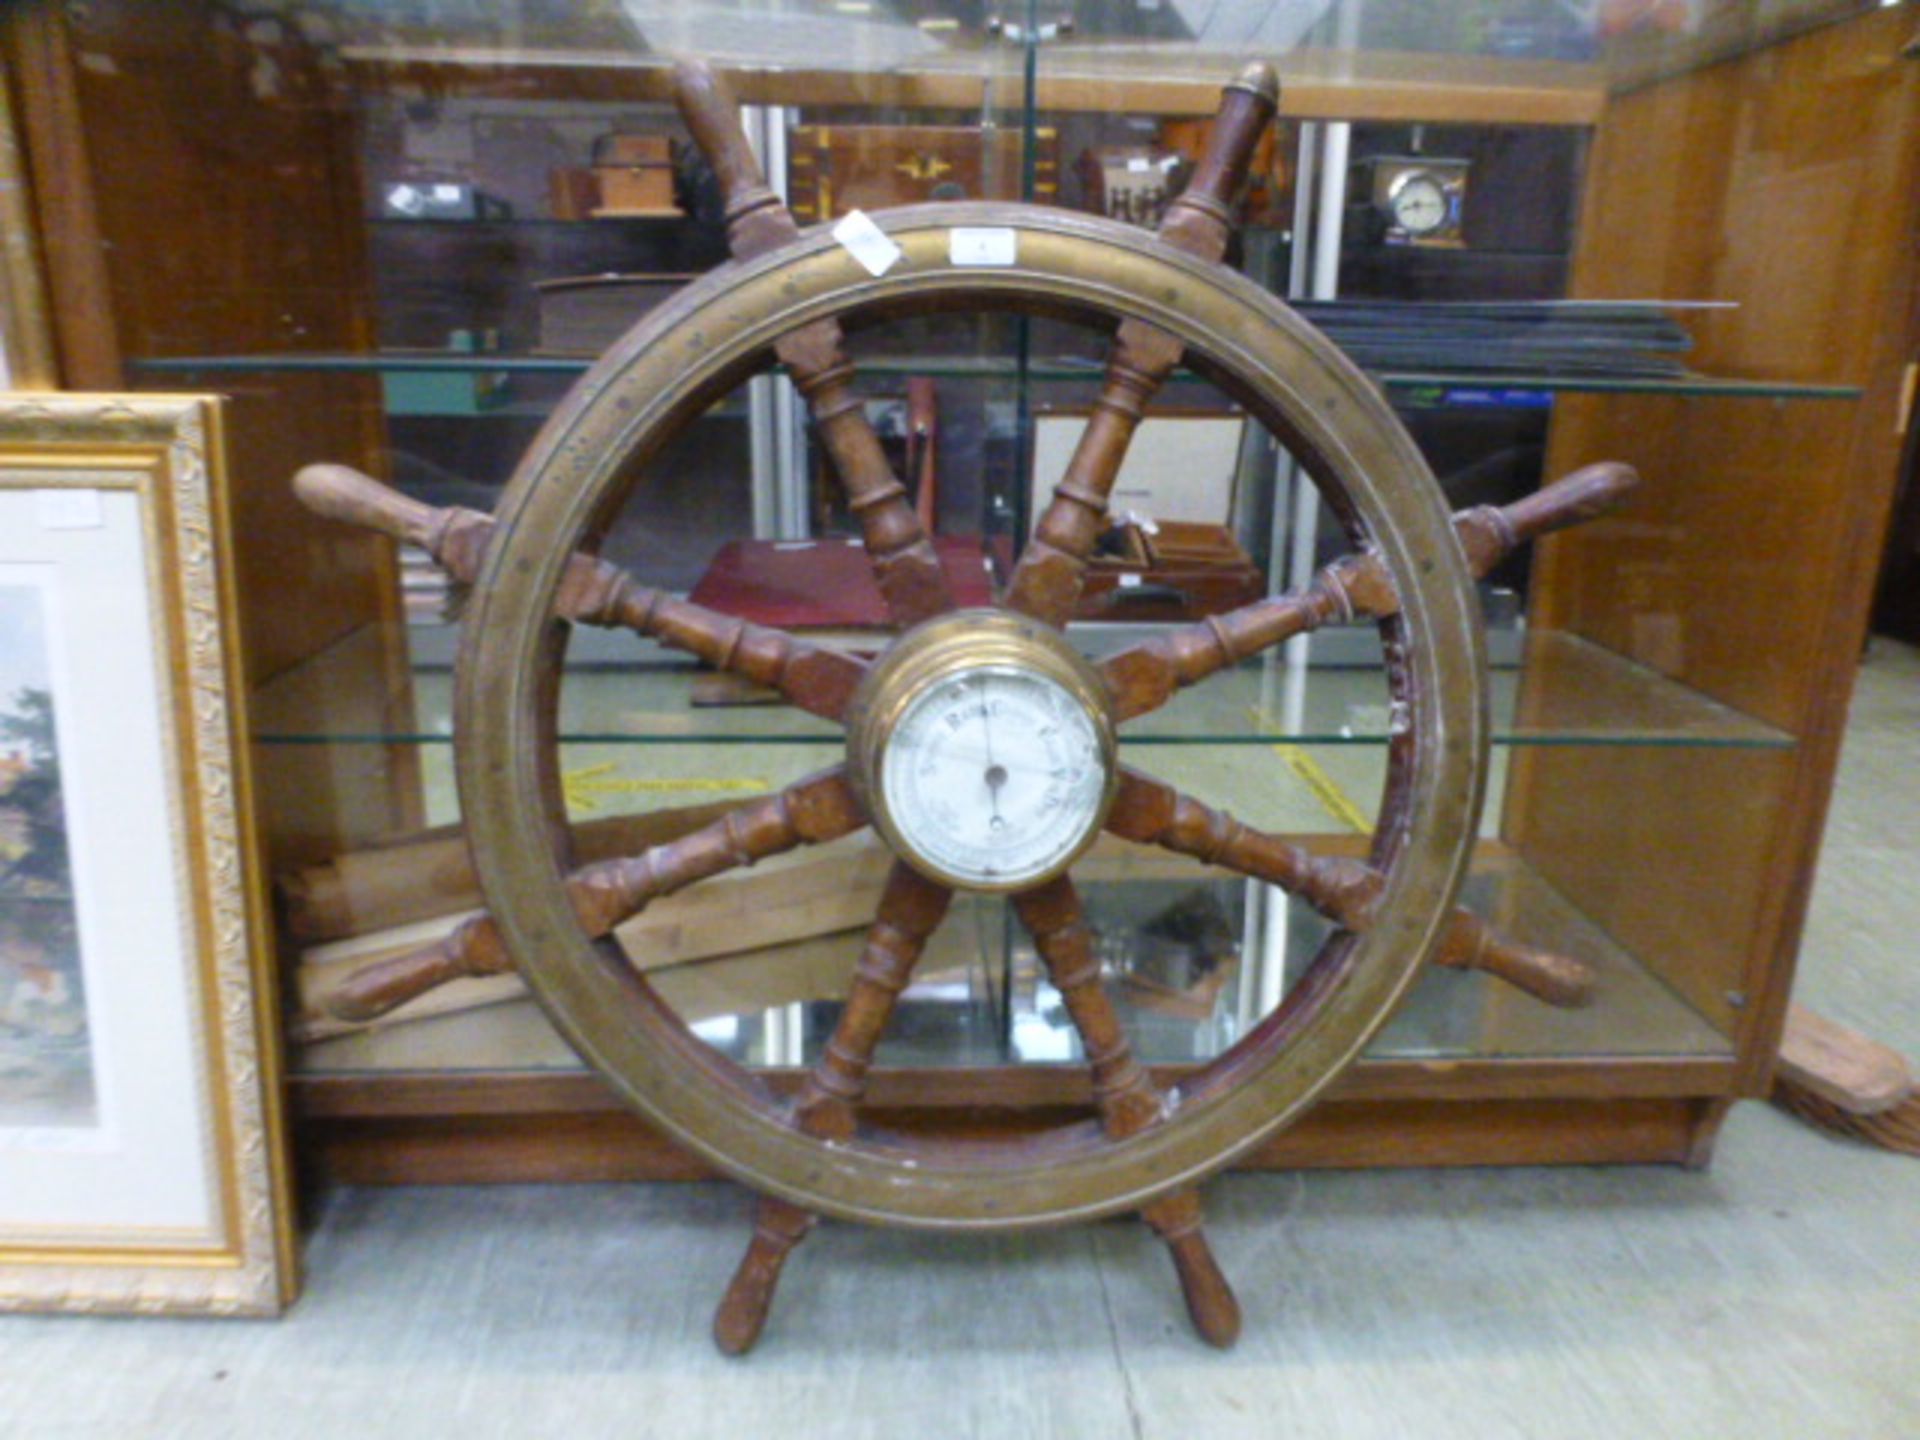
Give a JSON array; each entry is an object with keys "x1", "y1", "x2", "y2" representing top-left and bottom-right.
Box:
[{"x1": 877, "y1": 664, "x2": 1108, "y2": 889}]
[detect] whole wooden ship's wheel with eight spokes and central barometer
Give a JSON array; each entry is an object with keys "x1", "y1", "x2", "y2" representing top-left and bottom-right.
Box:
[{"x1": 298, "y1": 65, "x2": 1632, "y2": 1352}]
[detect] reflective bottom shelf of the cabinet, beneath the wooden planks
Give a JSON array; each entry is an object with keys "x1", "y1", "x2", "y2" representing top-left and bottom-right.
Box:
[{"x1": 294, "y1": 847, "x2": 1732, "y2": 1079}]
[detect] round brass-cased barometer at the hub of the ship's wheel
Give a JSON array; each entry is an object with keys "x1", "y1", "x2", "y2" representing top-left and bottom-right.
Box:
[{"x1": 852, "y1": 614, "x2": 1114, "y2": 891}]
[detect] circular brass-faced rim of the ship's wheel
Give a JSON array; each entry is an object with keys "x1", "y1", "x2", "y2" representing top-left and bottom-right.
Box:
[{"x1": 455, "y1": 204, "x2": 1486, "y2": 1229}]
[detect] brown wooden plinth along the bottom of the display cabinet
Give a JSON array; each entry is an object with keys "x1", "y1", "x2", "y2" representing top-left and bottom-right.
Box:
[{"x1": 300, "y1": 1096, "x2": 1730, "y2": 1185}]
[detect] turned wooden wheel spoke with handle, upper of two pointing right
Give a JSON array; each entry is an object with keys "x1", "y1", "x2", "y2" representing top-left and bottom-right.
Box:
[{"x1": 1100, "y1": 461, "x2": 1640, "y2": 720}]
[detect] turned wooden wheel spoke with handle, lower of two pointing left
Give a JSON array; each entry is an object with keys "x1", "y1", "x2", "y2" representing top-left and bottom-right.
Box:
[{"x1": 328, "y1": 766, "x2": 866, "y2": 1021}]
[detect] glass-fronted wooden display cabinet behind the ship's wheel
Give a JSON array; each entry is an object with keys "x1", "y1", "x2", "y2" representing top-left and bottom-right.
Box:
[{"x1": 6, "y1": 0, "x2": 1920, "y2": 1181}]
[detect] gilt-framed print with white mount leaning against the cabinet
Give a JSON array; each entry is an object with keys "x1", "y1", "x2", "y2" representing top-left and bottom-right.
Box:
[{"x1": 0, "y1": 394, "x2": 294, "y2": 1313}]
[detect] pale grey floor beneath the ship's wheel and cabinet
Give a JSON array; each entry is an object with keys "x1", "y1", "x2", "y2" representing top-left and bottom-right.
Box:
[{"x1": 0, "y1": 643, "x2": 1920, "y2": 1440}]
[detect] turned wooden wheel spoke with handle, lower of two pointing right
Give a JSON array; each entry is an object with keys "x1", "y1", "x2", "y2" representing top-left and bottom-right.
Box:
[{"x1": 1106, "y1": 770, "x2": 1594, "y2": 1008}]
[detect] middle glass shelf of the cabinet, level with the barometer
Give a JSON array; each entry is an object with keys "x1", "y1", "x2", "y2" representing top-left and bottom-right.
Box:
[{"x1": 253, "y1": 626, "x2": 1793, "y2": 749}]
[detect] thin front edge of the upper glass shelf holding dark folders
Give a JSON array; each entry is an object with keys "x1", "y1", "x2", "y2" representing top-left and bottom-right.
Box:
[{"x1": 129, "y1": 357, "x2": 1860, "y2": 399}]
